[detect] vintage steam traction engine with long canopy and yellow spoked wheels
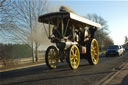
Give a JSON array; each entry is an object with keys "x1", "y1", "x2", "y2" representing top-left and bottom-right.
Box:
[{"x1": 38, "y1": 11, "x2": 101, "y2": 69}]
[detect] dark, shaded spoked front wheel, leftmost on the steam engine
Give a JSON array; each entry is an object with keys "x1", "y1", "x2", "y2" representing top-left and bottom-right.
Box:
[{"x1": 45, "y1": 46, "x2": 59, "y2": 69}]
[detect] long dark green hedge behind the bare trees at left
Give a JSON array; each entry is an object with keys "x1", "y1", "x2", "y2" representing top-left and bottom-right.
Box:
[{"x1": 0, "y1": 44, "x2": 32, "y2": 59}]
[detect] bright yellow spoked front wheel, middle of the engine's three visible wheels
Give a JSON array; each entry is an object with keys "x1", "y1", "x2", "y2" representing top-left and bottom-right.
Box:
[{"x1": 68, "y1": 45, "x2": 80, "y2": 69}]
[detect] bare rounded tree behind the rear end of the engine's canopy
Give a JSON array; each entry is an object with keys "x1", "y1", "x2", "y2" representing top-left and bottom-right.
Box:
[{"x1": 87, "y1": 14, "x2": 114, "y2": 50}]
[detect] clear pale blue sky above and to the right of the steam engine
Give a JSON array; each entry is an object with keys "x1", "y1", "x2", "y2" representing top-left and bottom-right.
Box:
[{"x1": 51, "y1": 0, "x2": 128, "y2": 45}]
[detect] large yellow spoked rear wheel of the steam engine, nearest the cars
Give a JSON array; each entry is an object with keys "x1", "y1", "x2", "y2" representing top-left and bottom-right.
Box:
[{"x1": 87, "y1": 39, "x2": 99, "y2": 65}]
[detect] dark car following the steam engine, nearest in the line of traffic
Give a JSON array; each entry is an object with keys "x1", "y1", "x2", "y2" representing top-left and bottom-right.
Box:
[{"x1": 106, "y1": 45, "x2": 124, "y2": 57}]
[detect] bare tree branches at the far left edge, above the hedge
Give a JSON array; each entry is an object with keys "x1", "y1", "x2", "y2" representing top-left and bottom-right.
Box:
[{"x1": 0, "y1": 0, "x2": 14, "y2": 43}]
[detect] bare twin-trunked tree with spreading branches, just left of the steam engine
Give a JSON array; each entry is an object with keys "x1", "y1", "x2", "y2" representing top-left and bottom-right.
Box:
[{"x1": 4, "y1": 0, "x2": 47, "y2": 62}]
